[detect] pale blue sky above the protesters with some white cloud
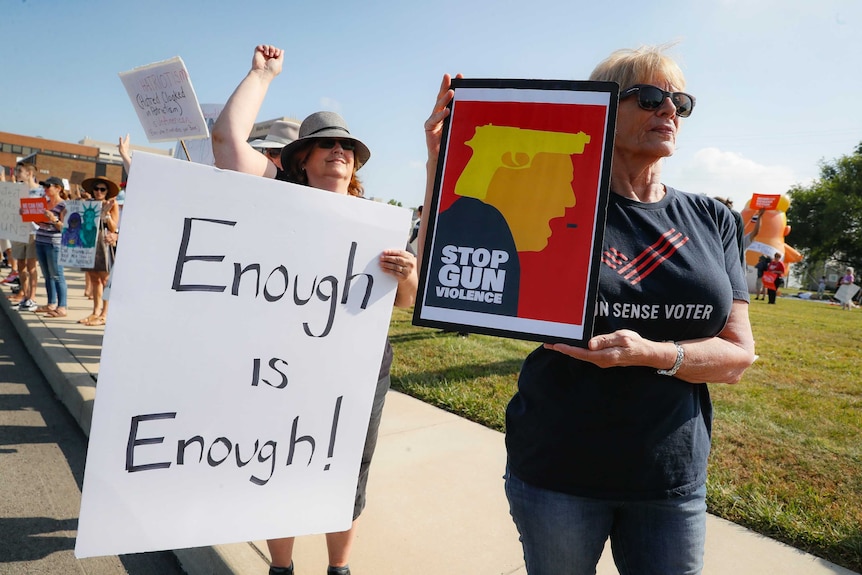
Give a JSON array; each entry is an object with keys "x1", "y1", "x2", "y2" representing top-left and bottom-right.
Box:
[{"x1": 0, "y1": 0, "x2": 862, "y2": 212}]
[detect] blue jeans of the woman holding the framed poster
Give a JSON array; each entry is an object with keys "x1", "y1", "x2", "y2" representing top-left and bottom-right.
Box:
[{"x1": 504, "y1": 469, "x2": 706, "y2": 575}]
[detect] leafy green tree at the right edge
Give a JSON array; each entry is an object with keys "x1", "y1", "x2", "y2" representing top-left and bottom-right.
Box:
[{"x1": 787, "y1": 142, "x2": 862, "y2": 277}]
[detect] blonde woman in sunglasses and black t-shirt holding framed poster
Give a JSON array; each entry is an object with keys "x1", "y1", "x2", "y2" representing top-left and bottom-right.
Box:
[{"x1": 420, "y1": 47, "x2": 755, "y2": 575}]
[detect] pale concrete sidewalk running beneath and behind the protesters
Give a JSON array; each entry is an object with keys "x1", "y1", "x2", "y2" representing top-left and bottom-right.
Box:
[{"x1": 0, "y1": 270, "x2": 858, "y2": 575}]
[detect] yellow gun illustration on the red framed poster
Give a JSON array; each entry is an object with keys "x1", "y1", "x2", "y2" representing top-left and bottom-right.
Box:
[{"x1": 455, "y1": 124, "x2": 590, "y2": 199}]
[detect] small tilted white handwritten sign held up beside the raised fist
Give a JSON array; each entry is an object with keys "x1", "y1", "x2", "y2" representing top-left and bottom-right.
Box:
[{"x1": 120, "y1": 56, "x2": 209, "y2": 142}]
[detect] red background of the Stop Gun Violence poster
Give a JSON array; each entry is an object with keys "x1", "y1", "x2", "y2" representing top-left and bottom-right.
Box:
[{"x1": 438, "y1": 100, "x2": 608, "y2": 325}]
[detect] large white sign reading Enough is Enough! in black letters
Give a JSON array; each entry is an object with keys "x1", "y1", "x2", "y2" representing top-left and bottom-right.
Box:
[{"x1": 75, "y1": 152, "x2": 410, "y2": 557}]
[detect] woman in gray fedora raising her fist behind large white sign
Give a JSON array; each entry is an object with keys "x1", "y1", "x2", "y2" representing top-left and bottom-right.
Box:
[{"x1": 212, "y1": 45, "x2": 419, "y2": 575}]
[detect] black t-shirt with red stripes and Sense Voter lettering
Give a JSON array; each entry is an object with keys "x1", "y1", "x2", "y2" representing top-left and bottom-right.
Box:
[{"x1": 506, "y1": 188, "x2": 748, "y2": 500}]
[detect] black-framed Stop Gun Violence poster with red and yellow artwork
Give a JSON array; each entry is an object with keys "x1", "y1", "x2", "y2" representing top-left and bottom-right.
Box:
[{"x1": 413, "y1": 78, "x2": 619, "y2": 347}]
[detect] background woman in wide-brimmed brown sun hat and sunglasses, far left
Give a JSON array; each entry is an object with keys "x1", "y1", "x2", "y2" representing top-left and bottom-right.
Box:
[{"x1": 78, "y1": 176, "x2": 120, "y2": 326}]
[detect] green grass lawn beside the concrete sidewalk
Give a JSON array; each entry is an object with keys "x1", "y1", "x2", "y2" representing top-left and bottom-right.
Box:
[{"x1": 390, "y1": 297, "x2": 862, "y2": 571}]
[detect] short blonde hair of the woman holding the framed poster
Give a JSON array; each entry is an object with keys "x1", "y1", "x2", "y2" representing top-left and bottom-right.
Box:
[{"x1": 590, "y1": 44, "x2": 685, "y2": 91}]
